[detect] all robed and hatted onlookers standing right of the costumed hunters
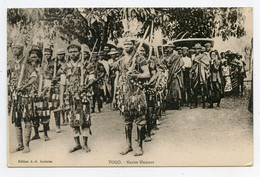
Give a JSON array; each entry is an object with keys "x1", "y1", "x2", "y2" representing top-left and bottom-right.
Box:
[{"x1": 166, "y1": 43, "x2": 246, "y2": 109}]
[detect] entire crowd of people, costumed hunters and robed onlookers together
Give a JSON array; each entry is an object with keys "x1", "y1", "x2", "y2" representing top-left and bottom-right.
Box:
[{"x1": 7, "y1": 31, "x2": 248, "y2": 156}]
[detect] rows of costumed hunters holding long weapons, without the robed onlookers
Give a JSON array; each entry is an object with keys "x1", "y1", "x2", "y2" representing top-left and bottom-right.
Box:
[{"x1": 7, "y1": 34, "x2": 170, "y2": 155}]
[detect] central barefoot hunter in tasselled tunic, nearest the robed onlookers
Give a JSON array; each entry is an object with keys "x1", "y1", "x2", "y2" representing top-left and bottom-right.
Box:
[{"x1": 116, "y1": 39, "x2": 150, "y2": 156}]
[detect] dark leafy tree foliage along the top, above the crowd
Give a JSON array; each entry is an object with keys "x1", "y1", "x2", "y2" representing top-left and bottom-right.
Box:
[{"x1": 7, "y1": 7, "x2": 246, "y2": 48}]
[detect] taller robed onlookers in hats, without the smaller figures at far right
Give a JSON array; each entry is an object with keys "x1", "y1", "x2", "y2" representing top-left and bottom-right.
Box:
[{"x1": 168, "y1": 43, "x2": 221, "y2": 109}]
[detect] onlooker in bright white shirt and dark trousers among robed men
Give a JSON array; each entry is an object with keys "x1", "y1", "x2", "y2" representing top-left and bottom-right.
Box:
[{"x1": 181, "y1": 47, "x2": 192, "y2": 106}]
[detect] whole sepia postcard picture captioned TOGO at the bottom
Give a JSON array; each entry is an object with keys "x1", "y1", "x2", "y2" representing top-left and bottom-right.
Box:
[{"x1": 6, "y1": 7, "x2": 256, "y2": 167}]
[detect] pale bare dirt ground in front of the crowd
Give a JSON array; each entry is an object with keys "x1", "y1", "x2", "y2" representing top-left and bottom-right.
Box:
[{"x1": 8, "y1": 97, "x2": 253, "y2": 166}]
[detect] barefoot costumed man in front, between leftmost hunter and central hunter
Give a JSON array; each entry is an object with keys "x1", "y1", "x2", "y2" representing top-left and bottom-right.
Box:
[{"x1": 63, "y1": 44, "x2": 91, "y2": 153}]
